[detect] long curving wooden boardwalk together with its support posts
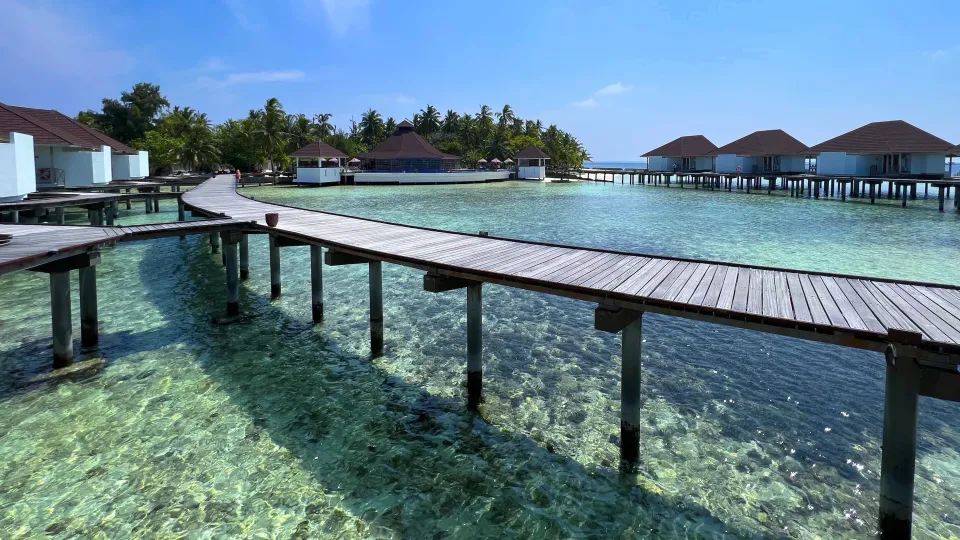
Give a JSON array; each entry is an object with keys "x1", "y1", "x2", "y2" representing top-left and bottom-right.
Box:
[{"x1": 0, "y1": 176, "x2": 960, "y2": 538}]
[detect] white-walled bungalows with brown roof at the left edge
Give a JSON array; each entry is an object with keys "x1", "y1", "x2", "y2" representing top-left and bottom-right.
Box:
[{"x1": 0, "y1": 103, "x2": 150, "y2": 198}]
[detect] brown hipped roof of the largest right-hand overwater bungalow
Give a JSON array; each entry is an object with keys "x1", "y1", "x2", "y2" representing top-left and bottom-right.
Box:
[{"x1": 807, "y1": 120, "x2": 952, "y2": 155}]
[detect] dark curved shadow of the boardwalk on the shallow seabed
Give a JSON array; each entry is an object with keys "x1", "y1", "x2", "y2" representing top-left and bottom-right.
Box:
[{"x1": 140, "y1": 238, "x2": 763, "y2": 538}]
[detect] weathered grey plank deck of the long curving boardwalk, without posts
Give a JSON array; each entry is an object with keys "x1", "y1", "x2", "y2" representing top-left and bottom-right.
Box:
[{"x1": 176, "y1": 176, "x2": 960, "y2": 354}]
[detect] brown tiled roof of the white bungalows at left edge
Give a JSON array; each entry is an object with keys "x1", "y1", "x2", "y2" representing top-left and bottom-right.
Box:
[{"x1": 0, "y1": 103, "x2": 137, "y2": 155}]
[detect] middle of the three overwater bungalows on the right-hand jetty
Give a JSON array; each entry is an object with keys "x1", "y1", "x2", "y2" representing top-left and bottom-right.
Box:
[{"x1": 706, "y1": 129, "x2": 807, "y2": 174}]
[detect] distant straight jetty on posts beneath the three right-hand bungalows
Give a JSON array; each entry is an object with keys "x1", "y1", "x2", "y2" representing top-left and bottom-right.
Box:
[{"x1": 574, "y1": 168, "x2": 960, "y2": 212}]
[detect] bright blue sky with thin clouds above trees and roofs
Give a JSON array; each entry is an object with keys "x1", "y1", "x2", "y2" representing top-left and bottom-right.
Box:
[{"x1": 0, "y1": 0, "x2": 960, "y2": 160}]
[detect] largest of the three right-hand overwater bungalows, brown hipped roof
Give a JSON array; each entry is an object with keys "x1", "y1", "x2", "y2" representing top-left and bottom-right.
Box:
[{"x1": 807, "y1": 120, "x2": 956, "y2": 178}]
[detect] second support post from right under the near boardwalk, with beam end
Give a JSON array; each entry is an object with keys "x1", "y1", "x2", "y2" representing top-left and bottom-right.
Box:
[{"x1": 593, "y1": 304, "x2": 644, "y2": 465}]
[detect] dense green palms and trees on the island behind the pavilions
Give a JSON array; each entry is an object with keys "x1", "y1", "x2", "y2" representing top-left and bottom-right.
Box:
[{"x1": 77, "y1": 83, "x2": 590, "y2": 172}]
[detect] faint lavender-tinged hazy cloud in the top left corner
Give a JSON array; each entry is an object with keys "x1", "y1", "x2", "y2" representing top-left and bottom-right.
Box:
[{"x1": 0, "y1": 0, "x2": 134, "y2": 84}]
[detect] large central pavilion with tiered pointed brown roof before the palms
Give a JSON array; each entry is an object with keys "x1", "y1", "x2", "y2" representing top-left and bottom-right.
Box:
[{"x1": 357, "y1": 120, "x2": 460, "y2": 173}]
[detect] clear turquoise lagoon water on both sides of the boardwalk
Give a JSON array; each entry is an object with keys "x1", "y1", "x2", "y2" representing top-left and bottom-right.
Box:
[{"x1": 0, "y1": 183, "x2": 960, "y2": 538}]
